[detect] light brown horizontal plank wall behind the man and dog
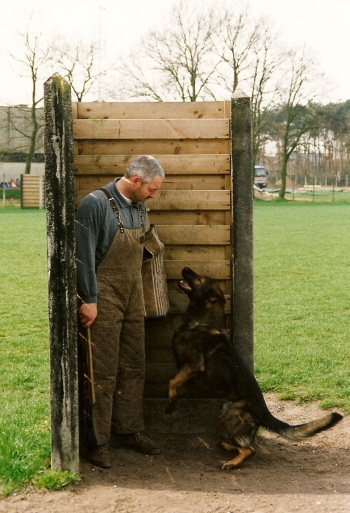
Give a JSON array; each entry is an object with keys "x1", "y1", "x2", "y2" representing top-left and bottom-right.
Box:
[{"x1": 72, "y1": 101, "x2": 232, "y2": 398}]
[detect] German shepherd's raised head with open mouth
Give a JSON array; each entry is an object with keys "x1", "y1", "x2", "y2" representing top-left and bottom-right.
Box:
[{"x1": 179, "y1": 267, "x2": 226, "y2": 307}]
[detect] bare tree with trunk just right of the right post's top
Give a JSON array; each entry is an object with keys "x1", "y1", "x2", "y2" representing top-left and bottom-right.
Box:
[{"x1": 215, "y1": 6, "x2": 283, "y2": 179}]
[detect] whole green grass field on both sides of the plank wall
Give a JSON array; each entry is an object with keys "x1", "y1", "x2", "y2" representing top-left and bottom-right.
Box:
[{"x1": 0, "y1": 201, "x2": 350, "y2": 494}]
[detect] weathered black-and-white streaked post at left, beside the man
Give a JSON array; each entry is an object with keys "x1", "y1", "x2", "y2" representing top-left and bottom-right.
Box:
[{"x1": 44, "y1": 74, "x2": 79, "y2": 472}]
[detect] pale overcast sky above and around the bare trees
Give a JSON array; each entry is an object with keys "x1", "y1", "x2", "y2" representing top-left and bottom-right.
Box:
[{"x1": 0, "y1": 0, "x2": 350, "y2": 105}]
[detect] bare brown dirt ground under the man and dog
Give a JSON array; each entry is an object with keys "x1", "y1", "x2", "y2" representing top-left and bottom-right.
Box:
[{"x1": 0, "y1": 394, "x2": 350, "y2": 513}]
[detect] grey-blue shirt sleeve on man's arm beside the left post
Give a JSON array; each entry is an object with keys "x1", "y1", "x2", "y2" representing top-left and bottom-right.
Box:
[{"x1": 75, "y1": 195, "x2": 102, "y2": 303}]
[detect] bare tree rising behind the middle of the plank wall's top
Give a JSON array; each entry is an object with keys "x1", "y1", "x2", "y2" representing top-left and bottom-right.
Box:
[{"x1": 113, "y1": 2, "x2": 220, "y2": 102}]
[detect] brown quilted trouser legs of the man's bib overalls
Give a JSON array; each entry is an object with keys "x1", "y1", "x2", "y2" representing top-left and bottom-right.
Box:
[{"x1": 91, "y1": 269, "x2": 145, "y2": 444}]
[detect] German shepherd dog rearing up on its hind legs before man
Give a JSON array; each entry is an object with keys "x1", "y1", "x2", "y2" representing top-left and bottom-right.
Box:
[{"x1": 166, "y1": 267, "x2": 342, "y2": 469}]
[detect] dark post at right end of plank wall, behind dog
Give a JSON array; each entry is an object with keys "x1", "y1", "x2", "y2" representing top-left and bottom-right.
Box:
[{"x1": 231, "y1": 91, "x2": 254, "y2": 371}]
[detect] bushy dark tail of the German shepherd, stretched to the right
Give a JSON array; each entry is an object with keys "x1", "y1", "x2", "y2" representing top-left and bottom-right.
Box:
[{"x1": 264, "y1": 413, "x2": 343, "y2": 441}]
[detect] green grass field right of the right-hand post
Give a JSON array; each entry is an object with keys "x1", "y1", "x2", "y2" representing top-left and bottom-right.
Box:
[{"x1": 254, "y1": 202, "x2": 350, "y2": 411}]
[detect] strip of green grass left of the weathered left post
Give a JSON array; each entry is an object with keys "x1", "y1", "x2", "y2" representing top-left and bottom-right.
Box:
[{"x1": 0, "y1": 208, "x2": 50, "y2": 493}]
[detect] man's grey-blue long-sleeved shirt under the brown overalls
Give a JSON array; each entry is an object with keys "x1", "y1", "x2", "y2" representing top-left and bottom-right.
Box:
[{"x1": 75, "y1": 179, "x2": 146, "y2": 303}]
